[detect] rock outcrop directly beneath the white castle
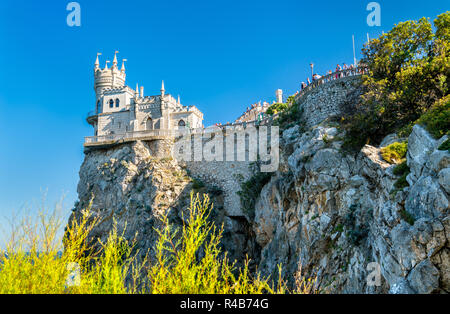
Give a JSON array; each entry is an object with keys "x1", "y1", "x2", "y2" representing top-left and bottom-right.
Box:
[{"x1": 70, "y1": 141, "x2": 256, "y2": 262}]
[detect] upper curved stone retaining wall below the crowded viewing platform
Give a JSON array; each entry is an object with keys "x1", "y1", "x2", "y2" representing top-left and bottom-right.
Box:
[{"x1": 295, "y1": 76, "x2": 361, "y2": 128}]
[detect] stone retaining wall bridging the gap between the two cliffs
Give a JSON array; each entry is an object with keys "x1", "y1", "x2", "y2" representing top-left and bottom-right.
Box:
[{"x1": 172, "y1": 126, "x2": 278, "y2": 218}]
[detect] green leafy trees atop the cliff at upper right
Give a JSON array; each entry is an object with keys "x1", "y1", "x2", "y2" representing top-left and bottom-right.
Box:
[{"x1": 345, "y1": 11, "x2": 450, "y2": 148}]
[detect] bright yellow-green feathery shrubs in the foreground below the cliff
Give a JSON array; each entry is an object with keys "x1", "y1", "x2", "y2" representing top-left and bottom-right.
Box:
[{"x1": 0, "y1": 195, "x2": 317, "y2": 294}]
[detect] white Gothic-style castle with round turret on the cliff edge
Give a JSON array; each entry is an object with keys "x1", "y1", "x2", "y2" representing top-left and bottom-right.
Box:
[{"x1": 87, "y1": 51, "x2": 203, "y2": 137}]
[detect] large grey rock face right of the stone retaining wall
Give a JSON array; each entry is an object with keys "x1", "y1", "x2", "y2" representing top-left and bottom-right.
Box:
[{"x1": 253, "y1": 126, "x2": 450, "y2": 293}]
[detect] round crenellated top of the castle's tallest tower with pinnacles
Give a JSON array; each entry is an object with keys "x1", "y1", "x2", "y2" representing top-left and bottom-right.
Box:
[{"x1": 94, "y1": 51, "x2": 126, "y2": 99}]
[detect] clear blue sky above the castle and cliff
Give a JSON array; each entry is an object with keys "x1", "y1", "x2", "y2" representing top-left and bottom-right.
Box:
[{"x1": 0, "y1": 0, "x2": 449, "y2": 233}]
